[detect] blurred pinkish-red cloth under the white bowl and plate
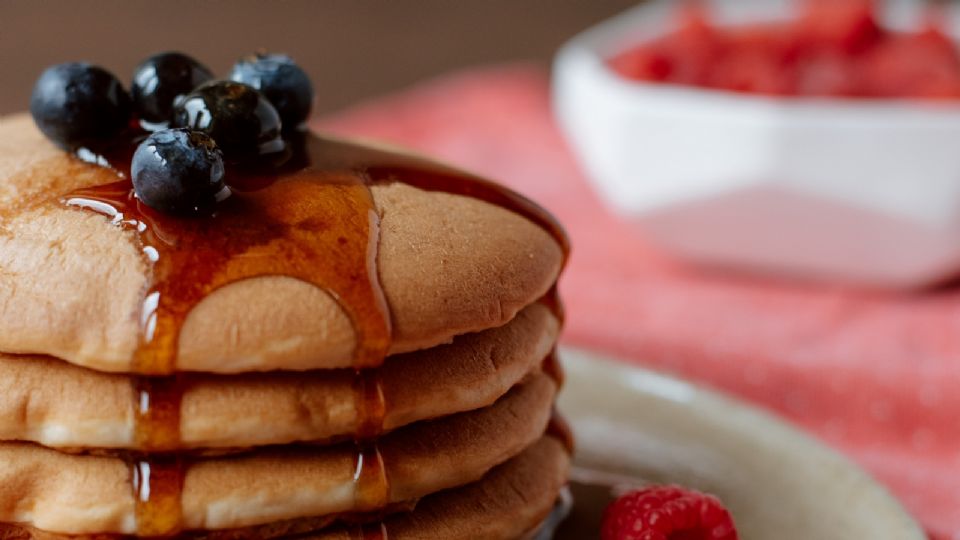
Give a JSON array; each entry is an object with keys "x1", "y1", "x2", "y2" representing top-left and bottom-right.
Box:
[{"x1": 315, "y1": 66, "x2": 960, "y2": 540}]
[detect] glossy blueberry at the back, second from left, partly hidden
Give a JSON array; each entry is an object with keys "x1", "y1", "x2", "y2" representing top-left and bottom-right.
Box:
[{"x1": 130, "y1": 52, "x2": 213, "y2": 123}]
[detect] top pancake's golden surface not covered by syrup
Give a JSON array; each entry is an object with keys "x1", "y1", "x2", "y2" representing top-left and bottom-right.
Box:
[{"x1": 0, "y1": 114, "x2": 563, "y2": 373}]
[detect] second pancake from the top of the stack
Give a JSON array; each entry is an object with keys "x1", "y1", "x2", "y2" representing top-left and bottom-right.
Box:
[{"x1": 0, "y1": 304, "x2": 559, "y2": 450}]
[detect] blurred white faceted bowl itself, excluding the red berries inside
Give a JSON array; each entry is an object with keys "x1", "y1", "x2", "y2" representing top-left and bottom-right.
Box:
[{"x1": 554, "y1": 0, "x2": 960, "y2": 288}]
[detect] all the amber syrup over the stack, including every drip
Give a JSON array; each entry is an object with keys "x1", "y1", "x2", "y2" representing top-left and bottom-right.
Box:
[{"x1": 64, "y1": 133, "x2": 572, "y2": 540}]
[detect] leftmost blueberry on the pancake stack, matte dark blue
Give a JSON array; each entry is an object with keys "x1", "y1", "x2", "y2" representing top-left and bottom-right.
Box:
[{"x1": 30, "y1": 62, "x2": 130, "y2": 150}]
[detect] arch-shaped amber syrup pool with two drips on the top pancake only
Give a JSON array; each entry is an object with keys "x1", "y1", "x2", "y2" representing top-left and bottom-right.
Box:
[{"x1": 66, "y1": 137, "x2": 390, "y2": 375}]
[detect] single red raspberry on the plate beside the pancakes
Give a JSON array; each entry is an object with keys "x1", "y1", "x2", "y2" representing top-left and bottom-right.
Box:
[{"x1": 600, "y1": 486, "x2": 738, "y2": 540}]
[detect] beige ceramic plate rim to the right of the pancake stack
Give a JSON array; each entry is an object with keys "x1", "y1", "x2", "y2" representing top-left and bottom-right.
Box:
[{"x1": 556, "y1": 348, "x2": 926, "y2": 540}]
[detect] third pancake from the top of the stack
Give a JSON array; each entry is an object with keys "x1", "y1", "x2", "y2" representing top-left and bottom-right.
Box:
[{"x1": 0, "y1": 374, "x2": 556, "y2": 534}]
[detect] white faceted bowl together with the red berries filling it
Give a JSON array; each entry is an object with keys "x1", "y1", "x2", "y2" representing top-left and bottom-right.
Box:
[{"x1": 554, "y1": 1, "x2": 960, "y2": 288}]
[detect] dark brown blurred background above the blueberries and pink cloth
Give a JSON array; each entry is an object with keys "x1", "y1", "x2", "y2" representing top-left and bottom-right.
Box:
[{"x1": 0, "y1": 0, "x2": 635, "y2": 114}]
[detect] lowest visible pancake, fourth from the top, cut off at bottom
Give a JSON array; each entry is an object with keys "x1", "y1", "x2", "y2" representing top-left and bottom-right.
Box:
[{"x1": 0, "y1": 437, "x2": 570, "y2": 540}]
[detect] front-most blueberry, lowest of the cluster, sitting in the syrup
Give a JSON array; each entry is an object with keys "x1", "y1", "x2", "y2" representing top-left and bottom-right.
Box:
[{"x1": 130, "y1": 129, "x2": 229, "y2": 215}]
